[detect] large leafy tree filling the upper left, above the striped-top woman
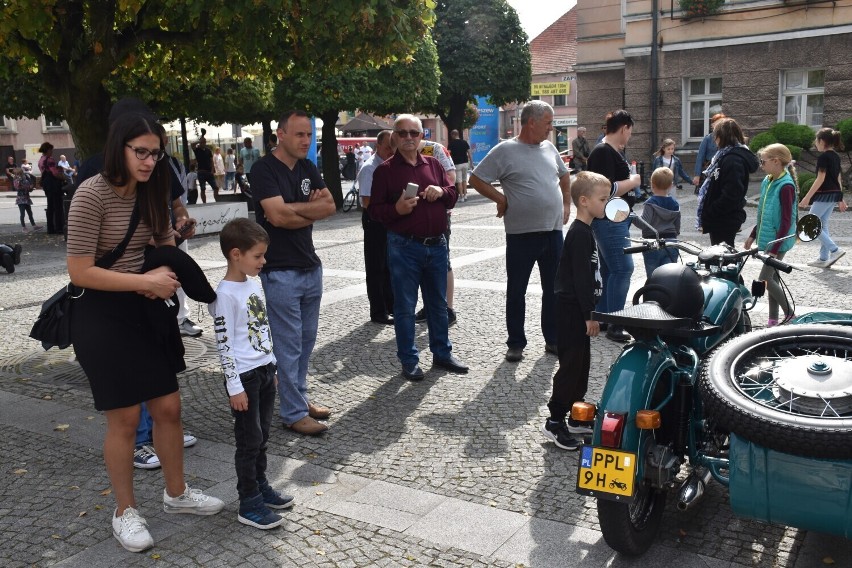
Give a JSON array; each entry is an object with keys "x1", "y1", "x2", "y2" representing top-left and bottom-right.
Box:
[{"x1": 0, "y1": 0, "x2": 434, "y2": 155}]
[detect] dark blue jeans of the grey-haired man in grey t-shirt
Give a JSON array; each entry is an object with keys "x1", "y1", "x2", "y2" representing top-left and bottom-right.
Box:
[{"x1": 506, "y1": 230, "x2": 564, "y2": 349}]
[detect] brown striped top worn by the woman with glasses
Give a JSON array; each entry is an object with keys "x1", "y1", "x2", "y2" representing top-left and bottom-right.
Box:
[{"x1": 67, "y1": 175, "x2": 172, "y2": 273}]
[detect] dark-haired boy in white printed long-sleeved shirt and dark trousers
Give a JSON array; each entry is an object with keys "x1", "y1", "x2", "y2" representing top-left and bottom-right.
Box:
[{"x1": 208, "y1": 217, "x2": 293, "y2": 530}]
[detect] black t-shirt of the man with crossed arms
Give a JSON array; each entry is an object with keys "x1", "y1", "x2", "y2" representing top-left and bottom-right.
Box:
[{"x1": 251, "y1": 154, "x2": 325, "y2": 270}]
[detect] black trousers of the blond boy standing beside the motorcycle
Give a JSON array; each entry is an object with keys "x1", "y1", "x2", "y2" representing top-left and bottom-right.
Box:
[{"x1": 547, "y1": 296, "x2": 592, "y2": 420}]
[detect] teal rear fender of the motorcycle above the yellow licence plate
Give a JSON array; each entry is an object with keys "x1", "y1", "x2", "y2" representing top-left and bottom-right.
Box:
[{"x1": 593, "y1": 344, "x2": 675, "y2": 468}]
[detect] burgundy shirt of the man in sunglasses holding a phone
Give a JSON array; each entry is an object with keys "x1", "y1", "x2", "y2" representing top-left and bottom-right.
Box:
[{"x1": 368, "y1": 152, "x2": 458, "y2": 238}]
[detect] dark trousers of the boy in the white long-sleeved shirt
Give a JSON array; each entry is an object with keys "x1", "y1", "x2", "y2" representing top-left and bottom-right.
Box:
[{"x1": 231, "y1": 364, "x2": 277, "y2": 501}]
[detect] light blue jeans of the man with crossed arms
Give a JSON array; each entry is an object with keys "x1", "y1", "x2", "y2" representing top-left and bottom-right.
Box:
[{"x1": 260, "y1": 266, "x2": 322, "y2": 426}]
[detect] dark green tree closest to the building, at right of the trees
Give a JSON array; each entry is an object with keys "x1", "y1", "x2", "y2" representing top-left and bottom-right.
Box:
[{"x1": 432, "y1": 0, "x2": 532, "y2": 131}]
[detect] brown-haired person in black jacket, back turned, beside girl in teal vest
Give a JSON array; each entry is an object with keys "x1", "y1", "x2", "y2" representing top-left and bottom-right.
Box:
[{"x1": 698, "y1": 118, "x2": 758, "y2": 246}]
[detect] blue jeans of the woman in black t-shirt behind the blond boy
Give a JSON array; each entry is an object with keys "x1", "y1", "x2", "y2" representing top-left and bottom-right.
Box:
[{"x1": 592, "y1": 219, "x2": 633, "y2": 313}]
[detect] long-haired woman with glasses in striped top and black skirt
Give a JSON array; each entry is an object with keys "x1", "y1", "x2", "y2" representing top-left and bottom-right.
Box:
[{"x1": 68, "y1": 113, "x2": 224, "y2": 552}]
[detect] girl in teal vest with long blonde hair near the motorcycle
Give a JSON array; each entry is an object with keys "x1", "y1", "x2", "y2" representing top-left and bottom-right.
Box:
[{"x1": 744, "y1": 144, "x2": 799, "y2": 327}]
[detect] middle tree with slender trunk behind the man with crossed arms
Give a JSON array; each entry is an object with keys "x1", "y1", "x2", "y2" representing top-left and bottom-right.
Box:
[{"x1": 275, "y1": 33, "x2": 440, "y2": 207}]
